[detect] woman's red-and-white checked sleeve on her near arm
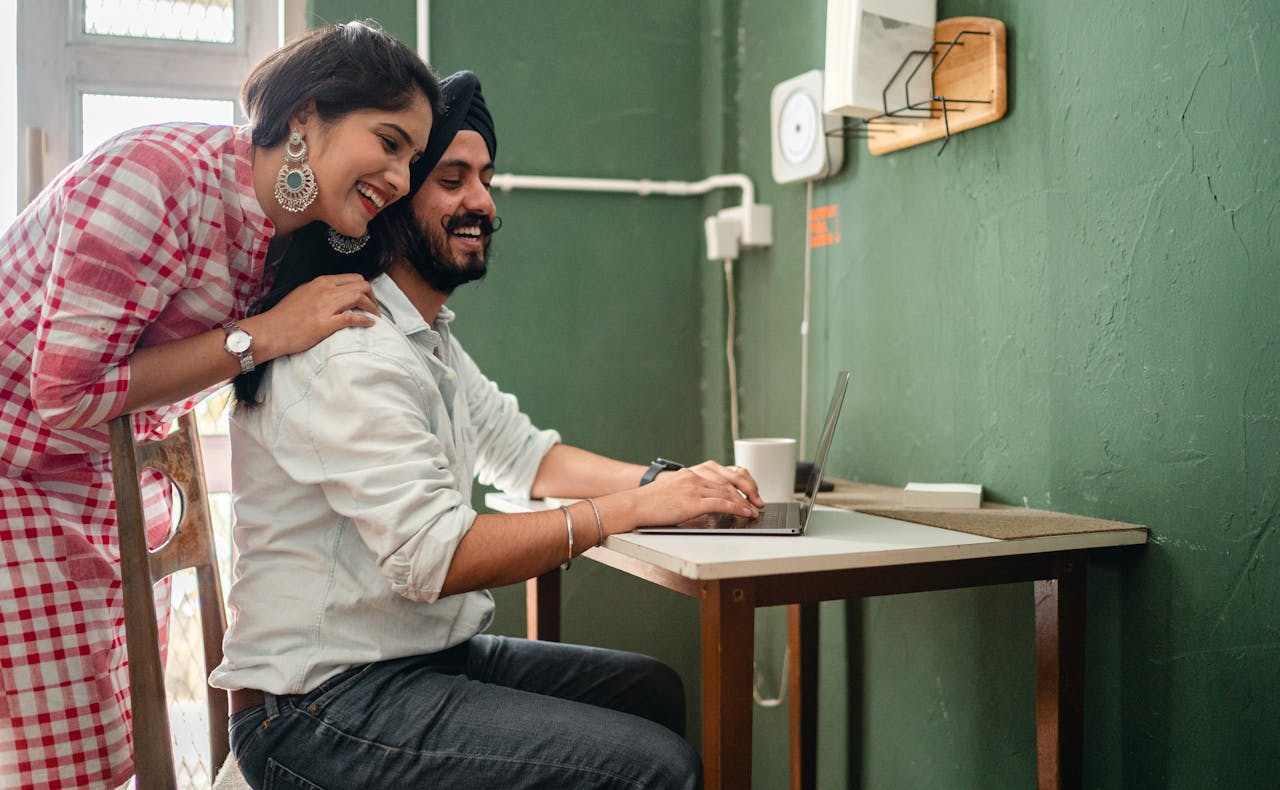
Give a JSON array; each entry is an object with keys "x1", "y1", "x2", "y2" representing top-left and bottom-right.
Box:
[{"x1": 31, "y1": 138, "x2": 195, "y2": 429}]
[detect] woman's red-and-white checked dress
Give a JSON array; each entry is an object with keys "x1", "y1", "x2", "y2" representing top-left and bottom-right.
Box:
[{"x1": 0, "y1": 124, "x2": 271, "y2": 787}]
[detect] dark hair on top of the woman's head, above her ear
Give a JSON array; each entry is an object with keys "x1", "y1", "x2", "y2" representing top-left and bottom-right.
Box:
[{"x1": 241, "y1": 22, "x2": 440, "y2": 147}]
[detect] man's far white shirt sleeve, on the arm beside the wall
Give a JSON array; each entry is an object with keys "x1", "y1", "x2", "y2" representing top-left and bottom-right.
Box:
[{"x1": 452, "y1": 342, "x2": 561, "y2": 497}]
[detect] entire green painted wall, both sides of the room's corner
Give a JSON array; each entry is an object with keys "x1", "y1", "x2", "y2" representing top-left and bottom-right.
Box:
[{"x1": 315, "y1": 0, "x2": 1280, "y2": 789}]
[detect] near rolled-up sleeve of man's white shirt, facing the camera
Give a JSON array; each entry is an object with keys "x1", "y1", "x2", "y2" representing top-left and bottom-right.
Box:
[{"x1": 270, "y1": 338, "x2": 476, "y2": 603}]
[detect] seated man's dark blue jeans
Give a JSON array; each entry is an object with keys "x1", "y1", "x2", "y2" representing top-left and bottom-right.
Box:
[{"x1": 230, "y1": 635, "x2": 703, "y2": 790}]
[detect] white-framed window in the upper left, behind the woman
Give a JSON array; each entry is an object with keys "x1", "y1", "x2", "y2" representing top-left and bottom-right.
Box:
[{"x1": 13, "y1": 0, "x2": 282, "y2": 218}]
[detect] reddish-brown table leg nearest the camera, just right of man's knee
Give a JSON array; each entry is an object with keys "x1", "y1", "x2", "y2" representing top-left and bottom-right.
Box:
[{"x1": 700, "y1": 579, "x2": 755, "y2": 790}]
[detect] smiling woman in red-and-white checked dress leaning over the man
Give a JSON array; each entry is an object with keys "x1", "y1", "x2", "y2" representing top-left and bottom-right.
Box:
[{"x1": 0, "y1": 23, "x2": 439, "y2": 787}]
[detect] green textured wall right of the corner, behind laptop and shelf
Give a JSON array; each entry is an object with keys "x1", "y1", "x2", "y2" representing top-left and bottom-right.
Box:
[{"x1": 721, "y1": 0, "x2": 1280, "y2": 787}]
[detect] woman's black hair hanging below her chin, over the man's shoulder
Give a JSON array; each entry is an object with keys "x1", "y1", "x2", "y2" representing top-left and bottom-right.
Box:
[{"x1": 234, "y1": 215, "x2": 394, "y2": 406}]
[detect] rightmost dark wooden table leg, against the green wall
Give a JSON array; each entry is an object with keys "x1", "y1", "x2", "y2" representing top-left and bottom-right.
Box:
[{"x1": 1036, "y1": 552, "x2": 1085, "y2": 790}]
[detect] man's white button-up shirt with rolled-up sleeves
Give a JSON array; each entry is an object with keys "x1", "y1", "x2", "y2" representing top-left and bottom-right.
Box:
[{"x1": 210, "y1": 275, "x2": 559, "y2": 694}]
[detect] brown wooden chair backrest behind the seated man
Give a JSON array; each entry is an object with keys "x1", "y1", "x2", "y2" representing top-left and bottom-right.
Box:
[{"x1": 110, "y1": 414, "x2": 229, "y2": 789}]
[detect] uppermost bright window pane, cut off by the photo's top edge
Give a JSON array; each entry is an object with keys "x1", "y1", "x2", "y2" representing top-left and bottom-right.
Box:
[{"x1": 84, "y1": 0, "x2": 236, "y2": 44}]
